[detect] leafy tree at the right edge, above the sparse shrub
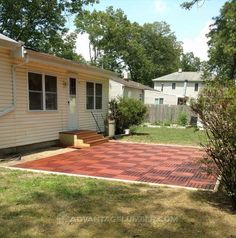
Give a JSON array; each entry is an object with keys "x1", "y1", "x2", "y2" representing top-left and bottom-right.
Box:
[{"x1": 208, "y1": 0, "x2": 236, "y2": 79}]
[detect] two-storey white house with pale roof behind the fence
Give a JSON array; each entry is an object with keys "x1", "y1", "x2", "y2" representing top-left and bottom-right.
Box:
[{"x1": 152, "y1": 70, "x2": 203, "y2": 104}]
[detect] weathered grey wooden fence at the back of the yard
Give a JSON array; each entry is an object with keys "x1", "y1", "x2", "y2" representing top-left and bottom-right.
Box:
[{"x1": 146, "y1": 105, "x2": 196, "y2": 123}]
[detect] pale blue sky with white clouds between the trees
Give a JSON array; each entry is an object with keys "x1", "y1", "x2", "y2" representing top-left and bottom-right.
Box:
[{"x1": 76, "y1": 0, "x2": 226, "y2": 60}]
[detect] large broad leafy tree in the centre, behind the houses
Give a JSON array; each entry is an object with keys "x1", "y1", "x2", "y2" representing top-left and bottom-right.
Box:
[{"x1": 75, "y1": 7, "x2": 181, "y2": 84}]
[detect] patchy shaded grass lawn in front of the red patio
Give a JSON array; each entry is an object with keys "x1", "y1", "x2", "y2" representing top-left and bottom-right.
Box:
[{"x1": 0, "y1": 168, "x2": 236, "y2": 238}]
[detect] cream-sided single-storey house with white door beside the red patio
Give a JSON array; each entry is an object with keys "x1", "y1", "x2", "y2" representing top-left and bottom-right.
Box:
[{"x1": 0, "y1": 34, "x2": 116, "y2": 150}]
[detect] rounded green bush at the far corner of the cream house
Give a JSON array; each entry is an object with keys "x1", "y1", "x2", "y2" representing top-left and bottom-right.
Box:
[{"x1": 109, "y1": 98, "x2": 147, "y2": 134}]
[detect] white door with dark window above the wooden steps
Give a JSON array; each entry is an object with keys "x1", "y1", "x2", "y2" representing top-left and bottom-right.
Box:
[{"x1": 68, "y1": 78, "x2": 78, "y2": 130}]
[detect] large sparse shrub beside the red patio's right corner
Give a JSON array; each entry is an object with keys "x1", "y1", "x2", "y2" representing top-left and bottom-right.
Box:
[{"x1": 191, "y1": 80, "x2": 236, "y2": 209}]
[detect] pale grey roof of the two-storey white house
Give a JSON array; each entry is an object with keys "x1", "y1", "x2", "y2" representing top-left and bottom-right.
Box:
[{"x1": 152, "y1": 72, "x2": 203, "y2": 82}]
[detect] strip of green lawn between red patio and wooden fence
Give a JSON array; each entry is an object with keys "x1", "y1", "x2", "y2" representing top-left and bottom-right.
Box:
[{"x1": 122, "y1": 127, "x2": 206, "y2": 146}]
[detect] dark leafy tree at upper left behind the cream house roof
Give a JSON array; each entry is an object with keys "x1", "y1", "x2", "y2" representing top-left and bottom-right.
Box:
[{"x1": 0, "y1": 0, "x2": 95, "y2": 59}]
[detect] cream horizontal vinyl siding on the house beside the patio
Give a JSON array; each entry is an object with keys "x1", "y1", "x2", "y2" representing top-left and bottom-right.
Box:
[{"x1": 0, "y1": 48, "x2": 108, "y2": 149}]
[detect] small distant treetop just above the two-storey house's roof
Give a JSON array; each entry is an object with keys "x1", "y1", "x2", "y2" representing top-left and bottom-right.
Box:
[{"x1": 180, "y1": 52, "x2": 201, "y2": 72}]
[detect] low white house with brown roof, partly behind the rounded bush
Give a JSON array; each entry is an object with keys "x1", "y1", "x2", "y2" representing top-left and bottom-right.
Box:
[{"x1": 109, "y1": 77, "x2": 177, "y2": 104}]
